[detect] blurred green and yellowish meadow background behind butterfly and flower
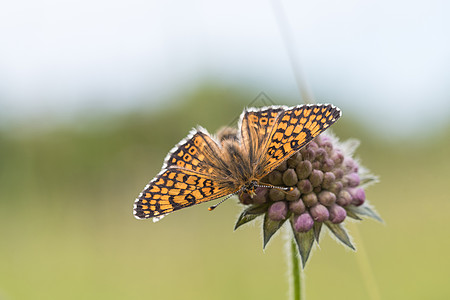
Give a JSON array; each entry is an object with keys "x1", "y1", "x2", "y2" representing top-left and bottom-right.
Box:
[{"x1": 0, "y1": 86, "x2": 450, "y2": 299}]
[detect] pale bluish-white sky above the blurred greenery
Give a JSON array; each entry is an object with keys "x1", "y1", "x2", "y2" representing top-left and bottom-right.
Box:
[{"x1": 0, "y1": 0, "x2": 450, "y2": 132}]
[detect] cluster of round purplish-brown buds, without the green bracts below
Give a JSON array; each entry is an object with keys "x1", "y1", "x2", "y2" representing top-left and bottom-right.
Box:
[{"x1": 239, "y1": 134, "x2": 366, "y2": 232}]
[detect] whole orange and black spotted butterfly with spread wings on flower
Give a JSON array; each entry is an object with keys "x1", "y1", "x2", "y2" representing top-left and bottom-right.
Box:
[{"x1": 134, "y1": 104, "x2": 341, "y2": 221}]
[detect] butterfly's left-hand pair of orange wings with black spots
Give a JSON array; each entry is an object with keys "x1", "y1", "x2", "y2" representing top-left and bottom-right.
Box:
[{"x1": 134, "y1": 129, "x2": 235, "y2": 219}]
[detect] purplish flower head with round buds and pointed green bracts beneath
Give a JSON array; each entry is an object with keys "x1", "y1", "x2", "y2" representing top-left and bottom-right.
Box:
[{"x1": 218, "y1": 128, "x2": 381, "y2": 266}]
